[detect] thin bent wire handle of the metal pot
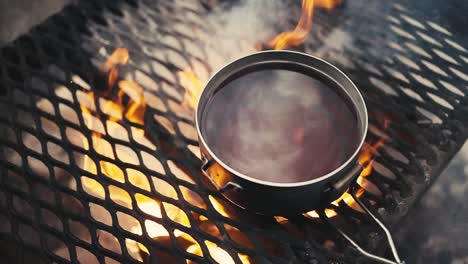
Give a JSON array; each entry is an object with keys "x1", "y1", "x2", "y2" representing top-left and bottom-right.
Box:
[{"x1": 318, "y1": 184, "x2": 405, "y2": 264}]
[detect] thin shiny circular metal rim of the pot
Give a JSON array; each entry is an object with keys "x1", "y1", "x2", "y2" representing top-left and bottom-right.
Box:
[{"x1": 195, "y1": 50, "x2": 369, "y2": 187}]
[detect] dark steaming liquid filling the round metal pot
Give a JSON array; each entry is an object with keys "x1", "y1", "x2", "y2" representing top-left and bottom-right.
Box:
[{"x1": 201, "y1": 70, "x2": 360, "y2": 183}]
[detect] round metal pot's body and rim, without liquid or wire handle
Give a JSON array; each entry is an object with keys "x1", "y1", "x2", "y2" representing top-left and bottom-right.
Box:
[{"x1": 196, "y1": 51, "x2": 368, "y2": 215}]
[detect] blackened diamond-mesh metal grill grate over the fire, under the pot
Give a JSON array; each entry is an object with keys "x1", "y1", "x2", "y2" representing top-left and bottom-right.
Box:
[{"x1": 0, "y1": 0, "x2": 468, "y2": 263}]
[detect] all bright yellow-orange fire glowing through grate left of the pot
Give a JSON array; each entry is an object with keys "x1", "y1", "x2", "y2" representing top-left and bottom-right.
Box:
[{"x1": 80, "y1": 48, "x2": 250, "y2": 263}]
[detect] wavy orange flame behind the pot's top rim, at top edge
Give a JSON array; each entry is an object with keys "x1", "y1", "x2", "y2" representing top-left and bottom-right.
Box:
[{"x1": 268, "y1": 0, "x2": 341, "y2": 50}]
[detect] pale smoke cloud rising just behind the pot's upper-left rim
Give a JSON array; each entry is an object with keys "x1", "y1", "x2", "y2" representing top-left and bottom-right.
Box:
[{"x1": 202, "y1": 0, "x2": 290, "y2": 71}]
